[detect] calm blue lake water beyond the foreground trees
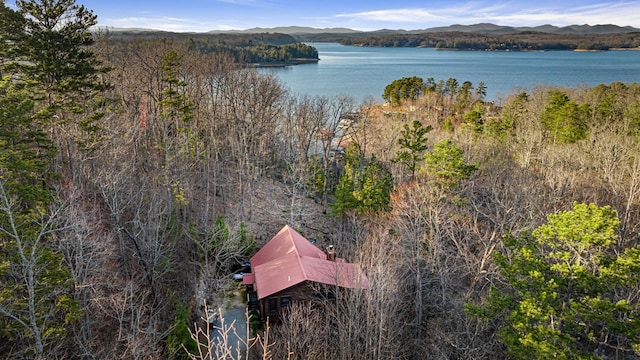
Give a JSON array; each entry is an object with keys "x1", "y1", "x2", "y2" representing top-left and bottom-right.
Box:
[{"x1": 260, "y1": 43, "x2": 640, "y2": 102}]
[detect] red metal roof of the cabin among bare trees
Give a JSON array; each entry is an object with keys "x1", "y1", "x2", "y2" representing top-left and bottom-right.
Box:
[{"x1": 250, "y1": 225, "x2": 369, "y2": 299}]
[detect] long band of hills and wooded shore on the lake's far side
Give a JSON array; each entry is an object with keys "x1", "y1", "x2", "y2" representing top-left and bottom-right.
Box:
[{"x1": 96, "y1": 23, "x2": 640, "y2": 52}]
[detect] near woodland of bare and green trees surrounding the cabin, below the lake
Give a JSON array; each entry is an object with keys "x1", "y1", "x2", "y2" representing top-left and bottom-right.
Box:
[{"x1": 0, "y1": 0, "x2": 640, "y2": 359}]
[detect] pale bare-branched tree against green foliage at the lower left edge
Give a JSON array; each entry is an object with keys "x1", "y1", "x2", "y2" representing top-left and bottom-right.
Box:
[{"x1": 0, "y1": 179, "x2": 78, "y2": 359}]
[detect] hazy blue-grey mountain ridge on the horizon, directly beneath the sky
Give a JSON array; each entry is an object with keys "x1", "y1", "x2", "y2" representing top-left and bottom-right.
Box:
[{"x1": 224, "y1": 23, "x2": 640, "y2": 35}]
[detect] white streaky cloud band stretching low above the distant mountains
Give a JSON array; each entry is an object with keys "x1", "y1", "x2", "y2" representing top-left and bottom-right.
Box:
[{"x1": 98, "y1": 0, "x2": 640, "y2": 32}]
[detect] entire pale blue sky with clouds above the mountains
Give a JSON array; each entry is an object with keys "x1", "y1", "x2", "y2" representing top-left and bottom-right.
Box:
[{"x1": 6, "y1": 0, "x2": 640, "y2": 32}]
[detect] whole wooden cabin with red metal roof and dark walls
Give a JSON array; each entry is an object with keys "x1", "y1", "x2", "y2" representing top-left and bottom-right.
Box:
[{"x1": 243, "y1": 225, "x2": 369, "y2": 320}]
